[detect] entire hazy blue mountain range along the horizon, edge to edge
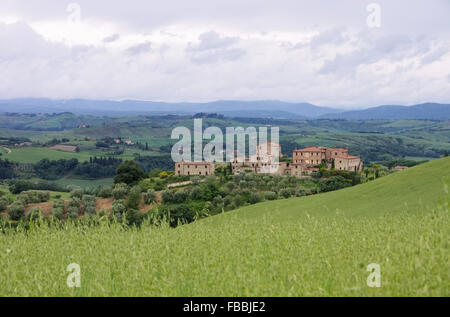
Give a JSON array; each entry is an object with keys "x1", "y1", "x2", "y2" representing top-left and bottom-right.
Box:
[{"x1": 0, "y1": 98, "x2": 450, "y2": 120}]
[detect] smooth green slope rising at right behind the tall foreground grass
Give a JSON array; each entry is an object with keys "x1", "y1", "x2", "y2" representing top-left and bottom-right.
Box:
[{"x1": 206, "y1": 157, "x2": 450, "y2": 223}]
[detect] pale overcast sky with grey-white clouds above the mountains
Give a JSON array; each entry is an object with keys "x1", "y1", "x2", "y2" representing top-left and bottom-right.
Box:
[{"x1": 0, "y1": 0, "x2": 450, "y2": 108}]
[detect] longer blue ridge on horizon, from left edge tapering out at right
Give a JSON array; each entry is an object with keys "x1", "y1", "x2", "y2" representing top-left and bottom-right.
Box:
[{"x1": 0, "y1": 98, "x2": 341, "y2": 119}]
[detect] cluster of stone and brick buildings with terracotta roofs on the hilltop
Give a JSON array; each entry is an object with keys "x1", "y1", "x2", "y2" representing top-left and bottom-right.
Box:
[{"x1": 175, "y1": 142, "x2": 363, "y2": 177}]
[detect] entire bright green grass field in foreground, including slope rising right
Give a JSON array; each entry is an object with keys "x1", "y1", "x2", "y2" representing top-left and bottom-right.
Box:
[{"x1": 0, "y1": 158, "x2": 450, "y2": 296}]
